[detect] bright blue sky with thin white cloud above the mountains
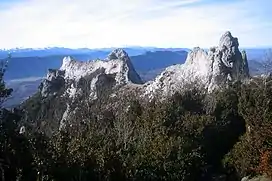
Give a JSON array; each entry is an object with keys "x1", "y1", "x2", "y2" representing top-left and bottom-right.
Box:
[{"x1": 0, "y1": 0, "x2": 272, "y2": 49}]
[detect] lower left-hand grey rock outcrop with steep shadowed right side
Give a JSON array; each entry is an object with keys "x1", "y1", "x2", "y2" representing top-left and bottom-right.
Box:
[{"x1": 40, "y1": 49, "x2": 142, "y2": 99}]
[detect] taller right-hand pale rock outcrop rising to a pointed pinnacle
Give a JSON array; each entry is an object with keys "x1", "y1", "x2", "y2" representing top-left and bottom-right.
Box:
[{"x1": 145, "y1": 32, "x2": 249, "y2": 97}]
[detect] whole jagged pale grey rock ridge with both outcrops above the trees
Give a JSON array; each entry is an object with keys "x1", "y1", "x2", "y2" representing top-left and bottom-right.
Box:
[{"x1": 30, "y1": 32, "x2": 249, "y2": 132}]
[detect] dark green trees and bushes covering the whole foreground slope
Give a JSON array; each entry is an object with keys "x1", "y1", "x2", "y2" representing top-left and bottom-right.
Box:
[{"x1": 0, "y1": 73, "x2": 272, "y2": 181}]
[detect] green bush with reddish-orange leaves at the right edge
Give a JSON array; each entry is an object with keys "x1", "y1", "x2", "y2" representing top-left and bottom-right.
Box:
[{"x1": 226, "y1": 77, "x2": 272, "y2": 176}]
